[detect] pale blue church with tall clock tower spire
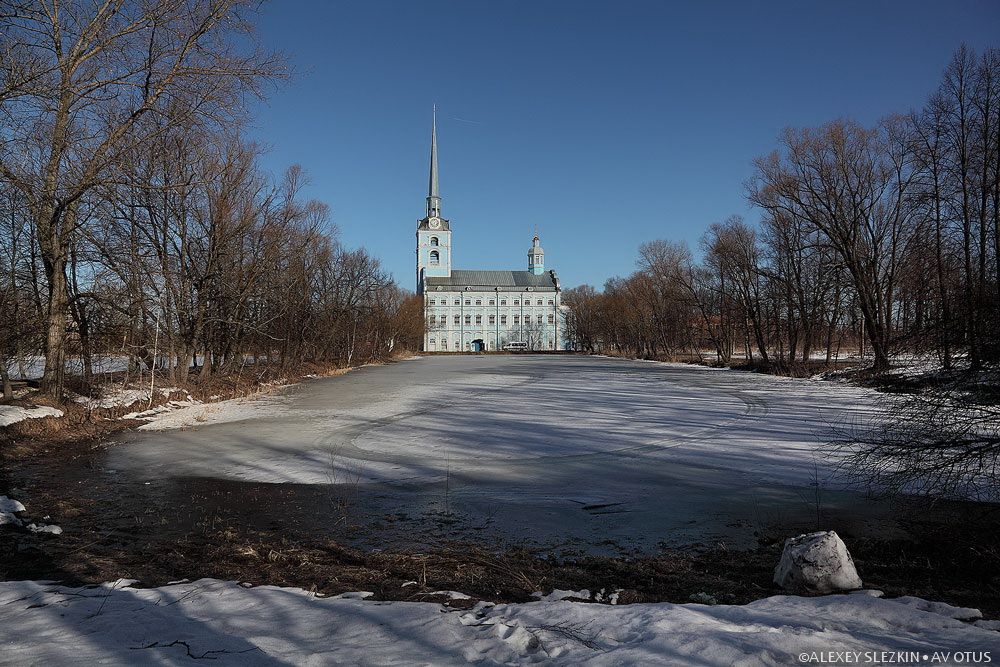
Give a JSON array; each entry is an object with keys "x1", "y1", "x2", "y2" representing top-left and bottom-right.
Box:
[{"x1": 417, "y1": 113, "x2": 565, "y2": 352}]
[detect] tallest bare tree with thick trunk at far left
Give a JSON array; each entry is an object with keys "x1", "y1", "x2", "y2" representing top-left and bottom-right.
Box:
[{"x1": 0, "y1": 0, "x2": 276, "y2": 398}]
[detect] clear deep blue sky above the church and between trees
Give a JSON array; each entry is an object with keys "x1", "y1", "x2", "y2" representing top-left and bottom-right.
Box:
[{"x1": 244, "y1": 0, "x2": 1000, "y2": 289}]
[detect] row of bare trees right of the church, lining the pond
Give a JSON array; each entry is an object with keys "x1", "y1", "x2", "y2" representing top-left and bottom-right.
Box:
[{"x1": 564, "y1": 46, "x2": 1000, "y2": 370}]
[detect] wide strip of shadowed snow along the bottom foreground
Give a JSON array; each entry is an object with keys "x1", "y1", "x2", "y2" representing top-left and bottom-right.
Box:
[{"x1": 0, "y1": 579, "x2": 1000, "y2": 666}]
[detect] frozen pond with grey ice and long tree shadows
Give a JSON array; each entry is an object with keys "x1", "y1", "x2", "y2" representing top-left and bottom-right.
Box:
[{"x1": 102, "y1": 355, "x2": 888, "y2": 553}]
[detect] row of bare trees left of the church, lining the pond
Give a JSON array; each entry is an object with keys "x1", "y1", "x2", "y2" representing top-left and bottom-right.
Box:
[{"x1": 0, "y1": 0, "x2": 422, "y2": 398}]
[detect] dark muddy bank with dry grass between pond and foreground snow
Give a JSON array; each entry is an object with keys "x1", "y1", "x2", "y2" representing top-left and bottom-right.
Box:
[{"x1": 0, "y1": 440, "x2": 1000, "y2": 617}]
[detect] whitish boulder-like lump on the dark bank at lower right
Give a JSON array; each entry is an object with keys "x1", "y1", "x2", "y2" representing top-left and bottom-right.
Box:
[{"x1": 774, "y1": 530, "x2": 861, "y2": 593}]
